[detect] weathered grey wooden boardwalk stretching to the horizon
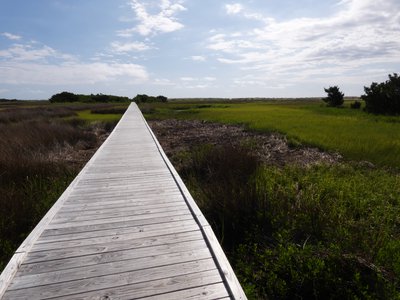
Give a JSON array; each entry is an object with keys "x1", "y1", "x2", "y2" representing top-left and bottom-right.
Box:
[{"x1": 0, "y1": 104, "x2": 246, "y2": 300}]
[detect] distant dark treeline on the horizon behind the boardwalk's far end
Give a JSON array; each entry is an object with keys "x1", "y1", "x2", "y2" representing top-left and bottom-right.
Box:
[{"x1": 49, "y1": 92, "x2": 168, "y2": 103}]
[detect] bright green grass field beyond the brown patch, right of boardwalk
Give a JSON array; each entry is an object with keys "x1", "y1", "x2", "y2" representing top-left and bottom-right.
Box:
[{"x1": 144, "y1": 101, "x2": 400, "y2": 168}]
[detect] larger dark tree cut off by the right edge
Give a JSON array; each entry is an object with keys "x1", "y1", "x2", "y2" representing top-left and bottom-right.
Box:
[{"x1": 361, "y1": 73, "x2": 400, "y2": 115}]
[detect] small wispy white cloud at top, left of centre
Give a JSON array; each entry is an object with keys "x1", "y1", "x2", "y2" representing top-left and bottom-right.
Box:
[{"x1": 128, "y1": 0, "x2": 186, "y2": 36}]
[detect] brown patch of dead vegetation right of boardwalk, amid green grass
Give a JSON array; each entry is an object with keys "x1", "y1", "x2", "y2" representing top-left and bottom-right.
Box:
[{"x1": 148, "y1": 119, "x2": 342, "y2": 166}]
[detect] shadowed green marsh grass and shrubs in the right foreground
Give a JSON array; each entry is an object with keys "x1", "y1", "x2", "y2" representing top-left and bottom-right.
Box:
[{"x1": 180, "y1": 146, "x2": 400, "y2": 299}]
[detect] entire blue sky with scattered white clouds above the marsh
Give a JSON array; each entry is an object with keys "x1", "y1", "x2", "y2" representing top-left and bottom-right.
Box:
[{"x1": 0, "y1": 0, "x2": 400, "y2": 99}]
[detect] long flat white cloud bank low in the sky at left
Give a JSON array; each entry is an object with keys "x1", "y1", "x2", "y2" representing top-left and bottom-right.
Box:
[{"x1": 0, "y1": 44, "x2": 148, "y2": 85}]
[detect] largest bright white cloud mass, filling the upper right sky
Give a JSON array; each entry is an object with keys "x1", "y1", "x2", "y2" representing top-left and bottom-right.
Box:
[{"x1": 208, "y1": 0, "x2": 400, "y2": 82}]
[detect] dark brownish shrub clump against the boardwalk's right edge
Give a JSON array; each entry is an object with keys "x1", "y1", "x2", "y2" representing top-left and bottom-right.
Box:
[{"x1": 181, "y1": 145, "x2": 261, "y2": 250}]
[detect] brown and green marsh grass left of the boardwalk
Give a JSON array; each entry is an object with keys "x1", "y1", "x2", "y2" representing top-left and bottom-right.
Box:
[{"x1": 0, "y1": 102, "x2": 126, "y2": 271}]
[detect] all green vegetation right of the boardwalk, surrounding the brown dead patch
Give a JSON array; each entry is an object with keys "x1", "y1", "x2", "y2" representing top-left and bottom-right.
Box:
[{"x1": 144, "y1": 102, "x2": 400, "y2": 299}]
